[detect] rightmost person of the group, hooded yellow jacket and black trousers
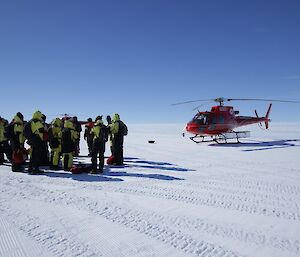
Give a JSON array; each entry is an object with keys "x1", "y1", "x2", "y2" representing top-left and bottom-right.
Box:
[{"x1": 110, "y1": 113, "x2": 128, "y2": 165}]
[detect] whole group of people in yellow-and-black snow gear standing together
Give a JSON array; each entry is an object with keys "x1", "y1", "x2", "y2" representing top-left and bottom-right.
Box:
[{"x1": 0, "y1": 111, "x2": 128, "y2": 174}]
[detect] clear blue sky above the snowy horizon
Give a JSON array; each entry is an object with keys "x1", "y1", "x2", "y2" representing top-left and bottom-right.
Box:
[{"x1": 0, "y1": 0, "x2": 300, "y2": 123}]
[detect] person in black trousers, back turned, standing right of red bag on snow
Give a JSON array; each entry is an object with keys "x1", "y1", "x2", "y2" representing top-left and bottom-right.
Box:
[{"x1": 91, "y1": 116, "x2": 108, "y2": 174}]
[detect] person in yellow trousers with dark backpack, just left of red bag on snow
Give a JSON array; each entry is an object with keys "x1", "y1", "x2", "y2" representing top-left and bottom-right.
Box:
[{"x1": 61, "y1": 120, "x2": 78, "y2": 171}]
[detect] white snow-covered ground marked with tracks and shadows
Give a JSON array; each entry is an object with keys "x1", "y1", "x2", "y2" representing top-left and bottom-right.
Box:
[{"x1": 0, "y1": 123, "x2": 300, "y2": 257}]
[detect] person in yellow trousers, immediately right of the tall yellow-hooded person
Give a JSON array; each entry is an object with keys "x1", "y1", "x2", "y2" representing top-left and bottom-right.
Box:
[{"x1": 48, "y1": 118, "x2": 62, "y2": 170}]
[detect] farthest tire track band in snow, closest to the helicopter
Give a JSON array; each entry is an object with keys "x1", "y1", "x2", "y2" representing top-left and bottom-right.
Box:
[{"x1": 16, "y1": 170, "x2": 300, "y2": 220}]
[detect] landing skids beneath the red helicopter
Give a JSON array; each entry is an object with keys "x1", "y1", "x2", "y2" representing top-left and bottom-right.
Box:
[{"x1": 190, "y1": 131, "x2": 250, "y2": 144}]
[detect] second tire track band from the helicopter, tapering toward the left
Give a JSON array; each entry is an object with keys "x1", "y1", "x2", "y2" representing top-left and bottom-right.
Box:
[{"x1": 105, "y1": 181, "x2": 300, "y2": 220}]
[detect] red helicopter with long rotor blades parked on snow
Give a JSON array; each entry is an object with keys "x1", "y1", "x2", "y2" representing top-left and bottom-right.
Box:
[{"x1": 173, "y1": 97, "x2": 300, "y2": 144}]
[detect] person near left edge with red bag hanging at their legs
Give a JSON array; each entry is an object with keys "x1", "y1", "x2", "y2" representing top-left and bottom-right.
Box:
[{"x1": 8, "y1": 112, "x2": 25, "y2": 172}]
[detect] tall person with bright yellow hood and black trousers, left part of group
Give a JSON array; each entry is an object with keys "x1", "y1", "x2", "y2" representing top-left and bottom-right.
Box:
[{"x1": 24, "y1": 111, "x2": 45, "y2": 174}]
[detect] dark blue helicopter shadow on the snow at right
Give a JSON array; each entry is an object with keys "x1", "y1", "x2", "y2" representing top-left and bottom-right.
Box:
[{"x1": 209, "y1": 139, "x2": 300, "y2": 152}]
